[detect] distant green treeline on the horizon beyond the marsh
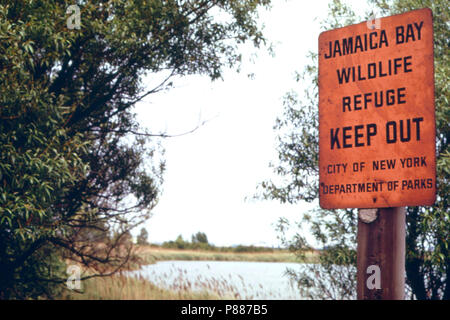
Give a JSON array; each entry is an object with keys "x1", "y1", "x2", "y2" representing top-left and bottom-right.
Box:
[{"x1": 151, "y1": 232, "x2": 276, "y2": 252}]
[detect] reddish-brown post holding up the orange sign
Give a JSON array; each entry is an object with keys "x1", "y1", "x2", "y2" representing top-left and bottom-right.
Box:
[{"x1": 357, "y1": 207, "x2": 406, "y2": 300}]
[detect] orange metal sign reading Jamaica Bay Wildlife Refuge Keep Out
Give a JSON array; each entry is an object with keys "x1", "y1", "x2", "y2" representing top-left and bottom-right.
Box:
[{"x1": 319, "y1": 9, "x2": 436, "y2": 209}]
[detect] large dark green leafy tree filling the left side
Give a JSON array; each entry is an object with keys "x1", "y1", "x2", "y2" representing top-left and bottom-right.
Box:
[{"x1": 0, "y1": 0, "x2": 270, "y2": 299}]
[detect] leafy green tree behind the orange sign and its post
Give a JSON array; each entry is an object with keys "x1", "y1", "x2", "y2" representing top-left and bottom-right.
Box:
[{"x1": 260, "y1": 0, "x2": 450, "y2": 299}]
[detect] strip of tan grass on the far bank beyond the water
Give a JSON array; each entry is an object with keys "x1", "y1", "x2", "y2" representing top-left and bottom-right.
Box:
[{"x1": 136, "y1": 246, "x2": 317, "y2": 264}]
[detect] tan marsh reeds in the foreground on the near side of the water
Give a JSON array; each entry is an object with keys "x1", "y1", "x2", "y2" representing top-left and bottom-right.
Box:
[{"x1": 61, "y1": 262, "x2": 292, "y2": 300}]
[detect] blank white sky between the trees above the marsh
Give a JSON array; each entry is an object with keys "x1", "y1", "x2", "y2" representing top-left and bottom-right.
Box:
[{"x1": 135, "y1": 0, "x2": 370, "y2": 246}]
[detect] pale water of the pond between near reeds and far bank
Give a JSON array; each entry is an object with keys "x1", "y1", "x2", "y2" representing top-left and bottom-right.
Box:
[{"x1": 131, "y1": 261, "x2": 301, "y2": 300}]
